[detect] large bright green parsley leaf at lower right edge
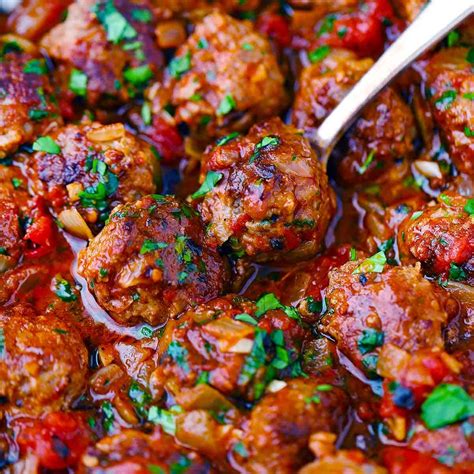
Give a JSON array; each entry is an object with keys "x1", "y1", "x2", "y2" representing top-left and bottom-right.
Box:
[{"x1": 421, "y1": 383, "x2": 474, "y2": 430}]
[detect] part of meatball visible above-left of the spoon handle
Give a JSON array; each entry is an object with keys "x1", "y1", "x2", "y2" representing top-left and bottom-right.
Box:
[{"x1": 292, "y1": 49, "x2": 374, "y2": 132}]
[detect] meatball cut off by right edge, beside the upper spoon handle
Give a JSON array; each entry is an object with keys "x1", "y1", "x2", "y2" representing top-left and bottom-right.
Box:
[{"x1": 427, "y1": 47, "x2": 474, "y2": 175}]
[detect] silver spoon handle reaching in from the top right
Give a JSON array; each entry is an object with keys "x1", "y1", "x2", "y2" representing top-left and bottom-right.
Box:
[{"x1": 312, "y1": 0, "x2": 474, "y2": 166}]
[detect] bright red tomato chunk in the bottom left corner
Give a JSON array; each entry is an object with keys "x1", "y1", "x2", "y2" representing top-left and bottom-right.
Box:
[{"x1": 17, "y1": 412, "x2": 90, "y2": 469}]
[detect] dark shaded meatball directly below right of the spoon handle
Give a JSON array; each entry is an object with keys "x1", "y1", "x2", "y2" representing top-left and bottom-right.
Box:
[{"x1": 338, "y1": 88, "x2": 416, "y2": 184}]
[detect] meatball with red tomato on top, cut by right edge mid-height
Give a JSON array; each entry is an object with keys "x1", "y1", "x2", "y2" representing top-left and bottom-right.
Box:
[{"x1": 398, "y1": 194, "x2": 474, "y2": 282}]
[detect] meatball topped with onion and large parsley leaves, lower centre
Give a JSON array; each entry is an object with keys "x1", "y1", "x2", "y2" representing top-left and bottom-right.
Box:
[{"x1": 150, "y1": 295, "x2": 306, "y2": 405}]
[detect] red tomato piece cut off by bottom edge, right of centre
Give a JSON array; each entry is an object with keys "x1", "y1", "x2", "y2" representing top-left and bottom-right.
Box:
[{"x1": 381, "y1": 446, "x2": 449, "y2": 474}]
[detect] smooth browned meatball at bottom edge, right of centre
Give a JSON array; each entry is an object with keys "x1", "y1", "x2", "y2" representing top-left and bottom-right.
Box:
[{"x1": 244, "y1": 378, "x2": 348, "y2": 474}]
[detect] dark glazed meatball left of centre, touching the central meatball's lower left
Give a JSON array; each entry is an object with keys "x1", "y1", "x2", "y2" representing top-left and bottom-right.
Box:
[{"x1": 79, "y1": 194, "x2": 228, "y2": 324}]
